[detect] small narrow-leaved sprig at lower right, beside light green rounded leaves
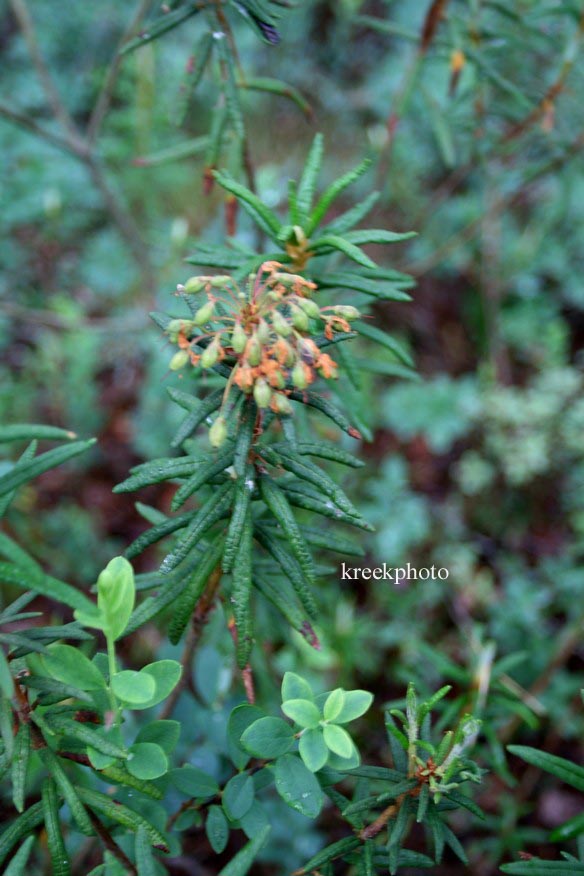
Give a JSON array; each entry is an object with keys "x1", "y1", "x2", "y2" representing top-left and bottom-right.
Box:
[{"x1": 288, "y1": 685, "x2": 484, "y2": 876}]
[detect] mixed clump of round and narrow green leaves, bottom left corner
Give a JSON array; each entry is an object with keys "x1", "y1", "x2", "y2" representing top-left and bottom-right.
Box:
[{"x1": 0, "y1": 557, "x2": 181, "y2": 876}]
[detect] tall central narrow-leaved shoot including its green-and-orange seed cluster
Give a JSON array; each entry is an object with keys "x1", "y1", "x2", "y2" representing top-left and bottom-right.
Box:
[{"x1": 116, "y1": 136, "x2": 411, "y2": 669}]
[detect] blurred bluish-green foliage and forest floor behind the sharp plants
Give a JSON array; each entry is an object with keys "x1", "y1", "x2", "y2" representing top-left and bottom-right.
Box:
[{"x1": 0, "y1": 0, "x2": 584, "y2": 874}]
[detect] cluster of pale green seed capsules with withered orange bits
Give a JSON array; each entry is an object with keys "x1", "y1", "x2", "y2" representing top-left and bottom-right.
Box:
[{"x1": 167, "y1": 261, "x2": 360, "y2": 440}]
